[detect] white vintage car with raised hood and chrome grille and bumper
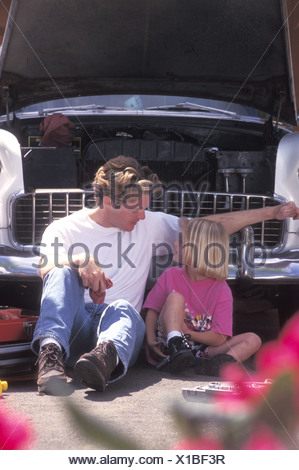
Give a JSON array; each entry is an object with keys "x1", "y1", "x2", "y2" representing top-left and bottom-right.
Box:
[{"x1": 0, "y1": 0, "x2": 299, "y2": 356}]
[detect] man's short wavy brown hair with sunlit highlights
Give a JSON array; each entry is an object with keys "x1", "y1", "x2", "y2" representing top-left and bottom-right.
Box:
[{"x1": 93, "y1": 155, "x2": 162, "y2": 206}]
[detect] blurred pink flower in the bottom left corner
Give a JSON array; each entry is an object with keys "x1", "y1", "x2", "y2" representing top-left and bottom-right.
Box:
[{"x1": 0, "y1": 401, "x2": 33, "y2": 450}]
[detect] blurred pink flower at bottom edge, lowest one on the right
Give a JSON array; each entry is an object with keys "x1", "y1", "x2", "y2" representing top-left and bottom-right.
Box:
[{"x1": 242, "y1": 424, "x2": 287, "y2": 450}]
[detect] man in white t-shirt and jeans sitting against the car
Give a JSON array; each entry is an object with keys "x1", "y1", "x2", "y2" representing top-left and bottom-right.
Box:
[{"x1": 32, "y1": 156, "x2": 299, "y2": 394}]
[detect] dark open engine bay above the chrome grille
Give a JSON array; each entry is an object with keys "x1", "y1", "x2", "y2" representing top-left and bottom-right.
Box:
[{"x1": 15, "y1": 116, "x2": 282, "y2": 196}]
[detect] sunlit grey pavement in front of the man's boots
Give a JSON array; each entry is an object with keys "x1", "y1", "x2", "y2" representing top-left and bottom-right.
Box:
[{"x1": 2, "y1": 356, "x2": 217, "y2": 450}]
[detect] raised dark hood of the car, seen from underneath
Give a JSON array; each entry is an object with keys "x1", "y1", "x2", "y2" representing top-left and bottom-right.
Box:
[{"x1": 0, "y1": 0, "x2": 297, "y2": 124}]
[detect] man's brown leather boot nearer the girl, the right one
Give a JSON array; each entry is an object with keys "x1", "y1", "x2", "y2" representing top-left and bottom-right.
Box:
[{"x1": 74, "y1": 341, "x2": 117, "y2": 392}]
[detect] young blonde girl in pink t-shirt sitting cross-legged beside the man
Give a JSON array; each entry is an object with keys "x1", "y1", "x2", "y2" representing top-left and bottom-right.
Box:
[{"x1": 144, "y1": 218, "x2": 261, "y2": 376}]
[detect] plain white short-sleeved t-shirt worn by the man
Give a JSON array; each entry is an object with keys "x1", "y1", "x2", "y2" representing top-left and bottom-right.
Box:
[{"x1": 40, "y1": 209, "x2": 179, "y2": 312}]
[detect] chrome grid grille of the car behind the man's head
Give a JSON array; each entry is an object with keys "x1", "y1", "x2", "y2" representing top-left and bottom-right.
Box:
[{"x1": 13, "y1": 190, "x2": 283, "y2": 248}]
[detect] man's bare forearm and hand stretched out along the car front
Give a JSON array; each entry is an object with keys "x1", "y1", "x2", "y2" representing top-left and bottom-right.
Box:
[{"x1": 205, "y1": 201, "x2": 299, "y2": 234}]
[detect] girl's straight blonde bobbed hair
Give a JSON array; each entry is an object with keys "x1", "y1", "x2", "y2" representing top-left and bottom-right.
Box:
[{"x1": 180, "y1": 217, "x2": 228, "y2": 281}]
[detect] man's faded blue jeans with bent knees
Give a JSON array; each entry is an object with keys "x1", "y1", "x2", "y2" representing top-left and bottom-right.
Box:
[{"x1": 32, "y1": 266, "x2": 145, "y2": 382}]
